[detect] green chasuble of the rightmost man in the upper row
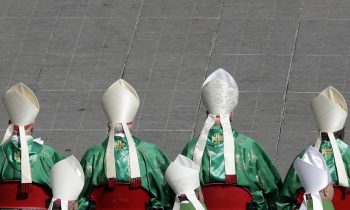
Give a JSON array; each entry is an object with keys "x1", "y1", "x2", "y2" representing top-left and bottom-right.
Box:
[{"x1": 277, "y1": 139, "x2": 350, "y2": 210}]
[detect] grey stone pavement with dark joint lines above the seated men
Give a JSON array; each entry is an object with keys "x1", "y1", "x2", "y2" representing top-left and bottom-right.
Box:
[{"x1": 0, "y1": 0, "x2": 350, "y2": 176}]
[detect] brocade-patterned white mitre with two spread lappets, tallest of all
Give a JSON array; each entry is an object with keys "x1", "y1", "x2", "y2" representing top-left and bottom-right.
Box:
[{"x1": 193, "y1": 69, "x2": 239, "y2": 184}]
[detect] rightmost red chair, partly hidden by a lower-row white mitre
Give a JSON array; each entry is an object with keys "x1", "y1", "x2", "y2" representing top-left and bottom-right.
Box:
[{"x1": 297, "y1": 186, "x2": 350, "y2": 210}]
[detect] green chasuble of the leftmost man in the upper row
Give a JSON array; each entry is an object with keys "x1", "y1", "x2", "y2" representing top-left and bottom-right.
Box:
[{"x1": 0, "y1": 138, "x2": 64, "y2": 186}]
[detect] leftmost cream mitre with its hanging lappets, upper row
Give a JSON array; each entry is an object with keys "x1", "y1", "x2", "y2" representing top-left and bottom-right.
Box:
[{"x1": 2, "y1": 83, "x2": 40, "y2": 189}]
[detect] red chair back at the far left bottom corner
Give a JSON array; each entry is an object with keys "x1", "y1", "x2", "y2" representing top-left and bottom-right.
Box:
[{"x1": 0, "y1": 180, "x2": 52, "y2": 209}]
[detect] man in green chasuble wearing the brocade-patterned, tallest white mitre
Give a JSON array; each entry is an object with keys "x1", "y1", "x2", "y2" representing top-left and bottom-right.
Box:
[{"x1": 182, "y1": 69, "x2": 281, "y2": 209}]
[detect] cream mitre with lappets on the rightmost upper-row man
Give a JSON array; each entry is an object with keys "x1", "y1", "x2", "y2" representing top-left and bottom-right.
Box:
[{"x1": 311, "y1": 86, "x2": 349, "y2": 187}]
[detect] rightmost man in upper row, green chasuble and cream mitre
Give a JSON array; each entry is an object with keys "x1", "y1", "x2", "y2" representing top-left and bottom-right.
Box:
[{"x1": 277, "y1": 86, "x2": 350, "y2": 210}]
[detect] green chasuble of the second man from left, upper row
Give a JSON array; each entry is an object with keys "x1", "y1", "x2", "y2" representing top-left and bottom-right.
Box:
[{"x1": 79, "y1": 136, "x2": 175, "y2": 210}]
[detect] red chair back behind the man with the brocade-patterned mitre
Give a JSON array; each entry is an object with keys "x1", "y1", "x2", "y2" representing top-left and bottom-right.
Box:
[{"x1": 202, "y1": 183, "x2": 254, "y2": 210}]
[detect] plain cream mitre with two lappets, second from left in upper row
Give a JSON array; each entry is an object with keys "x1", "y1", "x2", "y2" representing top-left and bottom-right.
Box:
[{"x1": 101, "y1": 79, "x2": 141, "y2": 188}]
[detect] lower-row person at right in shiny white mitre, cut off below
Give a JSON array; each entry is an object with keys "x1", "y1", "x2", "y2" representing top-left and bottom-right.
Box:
[{"x1": 293, "y1": 147, "x2": 334, "y2": 210}]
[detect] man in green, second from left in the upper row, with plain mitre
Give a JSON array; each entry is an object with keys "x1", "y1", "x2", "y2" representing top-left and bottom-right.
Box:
[{"x1": 79, "y1": 79, "x2": 174, "y2": 209}]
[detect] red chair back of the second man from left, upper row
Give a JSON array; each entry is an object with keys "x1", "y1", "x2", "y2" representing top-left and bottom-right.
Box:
[{"x1": 90, "y1": 183, "x2": 150, "y2": 210}]
